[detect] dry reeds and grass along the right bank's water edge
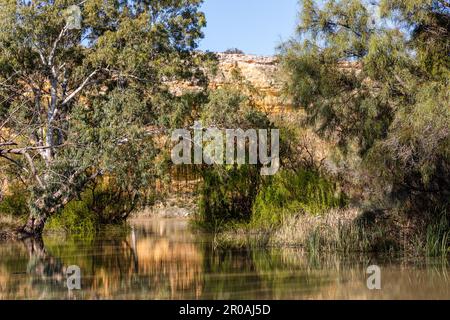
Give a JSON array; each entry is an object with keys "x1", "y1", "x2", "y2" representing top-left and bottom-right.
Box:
[{"x1": 214, "y1": 208, "x2": 450, "y2": 256}]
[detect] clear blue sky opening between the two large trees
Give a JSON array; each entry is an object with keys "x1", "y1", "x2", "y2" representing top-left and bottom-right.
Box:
[{"x1": 200, "y1": 0, "x2": 299, "y2": 55}]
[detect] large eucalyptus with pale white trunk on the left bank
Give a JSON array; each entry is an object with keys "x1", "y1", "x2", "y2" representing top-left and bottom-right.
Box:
[{"x1": 0, "y1": 0, "x2": 205, "y2": 236}]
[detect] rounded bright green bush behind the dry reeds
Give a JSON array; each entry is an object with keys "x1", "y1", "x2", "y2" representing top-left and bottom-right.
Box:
[{"x1": 252, "y1": 169, "x2": 346, "y2": 226}]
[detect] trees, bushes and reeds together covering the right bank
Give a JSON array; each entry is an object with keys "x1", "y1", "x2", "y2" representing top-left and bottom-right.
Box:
[{"x1": 194, "y1": 0, "x2": 450, "y2": 256}]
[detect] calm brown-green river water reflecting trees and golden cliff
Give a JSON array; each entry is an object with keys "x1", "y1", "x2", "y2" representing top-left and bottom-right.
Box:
[{"x1": 0, "y1": 219, "x2": 450, "y2": 299}]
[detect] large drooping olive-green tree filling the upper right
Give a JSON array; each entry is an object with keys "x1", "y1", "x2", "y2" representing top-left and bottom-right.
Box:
[{"x1": 281, "y1": 0, "x2": 450, "y2": 213}]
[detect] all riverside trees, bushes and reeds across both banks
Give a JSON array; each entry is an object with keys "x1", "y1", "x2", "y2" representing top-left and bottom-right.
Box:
[{"x1": 0, "y1": 0, "x2": 450, "y2": 256}]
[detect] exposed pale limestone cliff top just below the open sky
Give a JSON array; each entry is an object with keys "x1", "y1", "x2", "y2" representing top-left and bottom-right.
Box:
[{"x1": 210, "y1": 53, "x2": 291, "y2": 114}]
